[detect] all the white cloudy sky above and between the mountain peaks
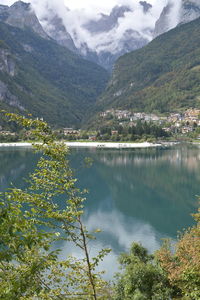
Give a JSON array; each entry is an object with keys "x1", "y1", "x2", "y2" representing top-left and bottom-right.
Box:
[{"x1": 0, "y1": 0, "x2": 181, "y2": 53}]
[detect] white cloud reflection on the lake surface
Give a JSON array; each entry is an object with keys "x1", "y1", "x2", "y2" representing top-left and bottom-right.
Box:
[{"x1": 56, "y1": 210, "x2": 166, "y2": 280}]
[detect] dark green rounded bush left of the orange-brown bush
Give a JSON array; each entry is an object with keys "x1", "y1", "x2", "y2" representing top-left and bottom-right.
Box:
[{"x1": 114, "y1": 243, "x2": 172, "y2": 300}]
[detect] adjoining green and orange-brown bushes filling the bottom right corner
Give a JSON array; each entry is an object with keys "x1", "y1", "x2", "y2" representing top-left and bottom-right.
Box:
[{"x1": 114, "y1": 204, "x2": 200, "y2": 300}]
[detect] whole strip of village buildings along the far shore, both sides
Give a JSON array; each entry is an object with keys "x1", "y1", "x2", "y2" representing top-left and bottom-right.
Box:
[{"x1": 0, "y1": 108, "x2": 200, "y2": 141}]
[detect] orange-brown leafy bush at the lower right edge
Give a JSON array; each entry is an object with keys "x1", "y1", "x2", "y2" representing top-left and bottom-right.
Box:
[{"x1": 156, "y1": 209, "x2": 200, "y2": 300}]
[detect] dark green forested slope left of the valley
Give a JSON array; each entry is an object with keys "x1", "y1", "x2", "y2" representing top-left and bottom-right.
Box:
[{"x1": 0, "y1": 23, "x2": 108, "y2": 127}]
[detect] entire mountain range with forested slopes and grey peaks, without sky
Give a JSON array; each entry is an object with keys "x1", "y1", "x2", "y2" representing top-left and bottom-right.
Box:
[{"x1": 0, "y1": 0, "x2": 200, "y2": 128}]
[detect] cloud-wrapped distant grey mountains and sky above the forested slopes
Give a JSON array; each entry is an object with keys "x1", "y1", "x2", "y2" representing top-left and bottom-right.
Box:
[{"x1": 0, "y1": 0, "x2": 200, "y2": 69}]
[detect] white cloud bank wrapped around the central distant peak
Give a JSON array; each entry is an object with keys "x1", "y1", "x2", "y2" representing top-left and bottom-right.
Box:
[{"x1": 54, "y1": 0, "x2": 167, "y2": 53}]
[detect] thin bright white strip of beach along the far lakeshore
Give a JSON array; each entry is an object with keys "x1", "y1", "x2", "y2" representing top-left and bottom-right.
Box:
[{"x1": 0, "y1": 142, "x2": 174, "y2": 149}]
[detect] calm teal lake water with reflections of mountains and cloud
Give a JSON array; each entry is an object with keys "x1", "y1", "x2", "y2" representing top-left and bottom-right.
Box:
[{"x1": 0, "y1": 145, "x2": 200, "y2": 277}]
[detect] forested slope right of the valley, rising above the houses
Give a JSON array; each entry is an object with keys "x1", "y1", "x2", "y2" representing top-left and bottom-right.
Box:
[{"x1": 97, "y1": 19, "x2": 200, "y2": 112}]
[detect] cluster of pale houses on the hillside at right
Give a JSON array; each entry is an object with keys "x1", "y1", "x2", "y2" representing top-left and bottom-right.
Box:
[{"x1": 100, "y1": 108, "x2": 200, "y2": 134}]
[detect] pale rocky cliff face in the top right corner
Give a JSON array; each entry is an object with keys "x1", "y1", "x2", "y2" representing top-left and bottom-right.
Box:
[{"x1": 153, "y1": 0, "x2": 200, "y2": 37}]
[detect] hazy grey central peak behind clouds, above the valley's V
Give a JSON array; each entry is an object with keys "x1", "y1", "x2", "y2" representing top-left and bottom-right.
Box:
[{"x1": 80, "y1": 5, "x2": 148, "y2": 70}]
